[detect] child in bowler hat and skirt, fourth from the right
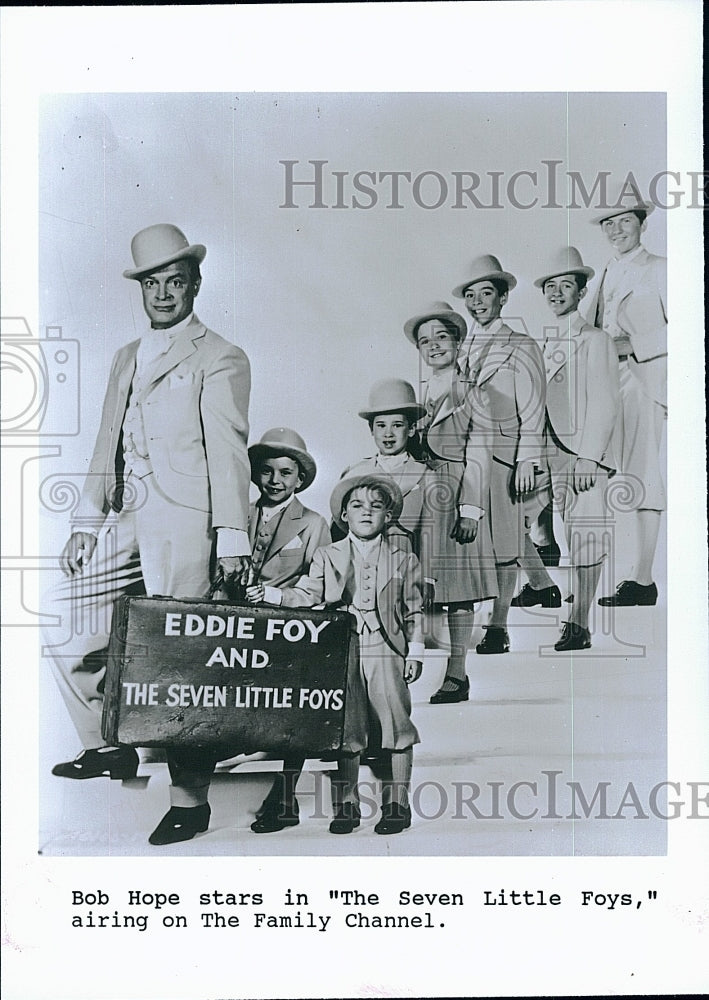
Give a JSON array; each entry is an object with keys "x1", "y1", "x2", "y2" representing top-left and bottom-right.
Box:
[{"x1": 404, "y1": 302, "x2": 497, "y2": 705}]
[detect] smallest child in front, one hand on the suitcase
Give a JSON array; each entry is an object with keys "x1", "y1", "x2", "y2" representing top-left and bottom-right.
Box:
[{"x1": 253, "y1": 475, "x2": 424, "y2": 834}]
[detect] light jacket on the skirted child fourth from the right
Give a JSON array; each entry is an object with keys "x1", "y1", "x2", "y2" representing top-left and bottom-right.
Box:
[{"x1": 424, "y1": 372, "x2": 493, "y2": 510}]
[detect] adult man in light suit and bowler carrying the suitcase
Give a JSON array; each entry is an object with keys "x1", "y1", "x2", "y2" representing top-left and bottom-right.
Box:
[{"x1": 45, "y1": 224, "x2": 250, "y2": 843}]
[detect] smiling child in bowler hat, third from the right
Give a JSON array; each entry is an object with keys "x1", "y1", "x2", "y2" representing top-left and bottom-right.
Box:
[{"x1": 453, "y1": 254, "x2": 546, "y2": 653}]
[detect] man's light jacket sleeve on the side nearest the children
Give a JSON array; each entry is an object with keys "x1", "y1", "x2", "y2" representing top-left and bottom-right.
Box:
[{"x1": 200, "y1": 338, "x2": 251, "y2": 531}]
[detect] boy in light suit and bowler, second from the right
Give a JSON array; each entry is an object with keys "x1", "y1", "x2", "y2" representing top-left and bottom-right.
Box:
[{"x1": 517, "y1": 247, "x2": 620, "y2": 652}]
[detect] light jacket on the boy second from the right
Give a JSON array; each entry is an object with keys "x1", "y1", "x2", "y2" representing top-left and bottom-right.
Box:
[{"x1": 544, "y1": 313, "x2": 620, "y2": 469}]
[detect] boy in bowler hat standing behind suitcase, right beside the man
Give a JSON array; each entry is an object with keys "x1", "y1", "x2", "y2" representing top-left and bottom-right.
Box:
[{"x1": 246, "y1": 427, "x2": 330, "y2": 833}]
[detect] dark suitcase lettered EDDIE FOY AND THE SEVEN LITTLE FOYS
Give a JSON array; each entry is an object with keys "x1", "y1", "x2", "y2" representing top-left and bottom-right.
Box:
[{"x1": 102, "y1": 596, "x2": 367, "y2": 759}]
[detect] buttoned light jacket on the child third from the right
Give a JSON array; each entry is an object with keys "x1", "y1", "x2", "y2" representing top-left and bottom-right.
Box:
[{"x1": 468, "y1": 323, "x2": 546, "y2": 466}]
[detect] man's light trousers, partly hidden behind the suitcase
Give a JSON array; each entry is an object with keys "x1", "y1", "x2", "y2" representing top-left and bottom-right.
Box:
[{"x1": 42, "y1": 475, "x2": 213, "y2": 784}]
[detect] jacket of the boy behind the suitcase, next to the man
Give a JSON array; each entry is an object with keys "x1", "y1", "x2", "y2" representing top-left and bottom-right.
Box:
[{"x1": 249, "y1": 497, "x2": 330, "y2": 587}]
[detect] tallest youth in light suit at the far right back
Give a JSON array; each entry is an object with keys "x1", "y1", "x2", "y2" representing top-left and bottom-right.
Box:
[{"x1": 586, "y1": 179, "x2": 667, "y2": 607}]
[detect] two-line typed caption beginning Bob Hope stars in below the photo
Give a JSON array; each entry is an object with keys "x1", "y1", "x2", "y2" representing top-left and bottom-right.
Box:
[{"x1": 69, "y1": 888, "x2": 657, "y2": 933}]
